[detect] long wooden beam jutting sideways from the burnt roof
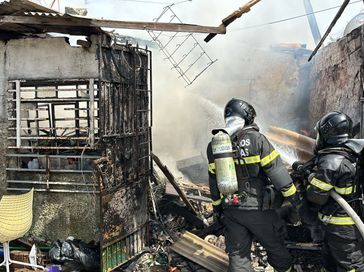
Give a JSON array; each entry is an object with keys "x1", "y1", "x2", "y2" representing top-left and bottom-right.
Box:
[{"x1": 0, "y1": 15, "x2": 226, "y2": 34}]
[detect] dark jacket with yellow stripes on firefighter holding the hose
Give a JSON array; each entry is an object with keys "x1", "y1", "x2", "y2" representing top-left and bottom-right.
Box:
[{"x1": 306, "y1": 147, "x2": 359, "y2": 225}]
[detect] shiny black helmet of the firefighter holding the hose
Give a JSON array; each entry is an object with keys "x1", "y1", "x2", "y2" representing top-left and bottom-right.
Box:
[{"x1": 315, "y1": 111, "x2": 353, "y2": 149}]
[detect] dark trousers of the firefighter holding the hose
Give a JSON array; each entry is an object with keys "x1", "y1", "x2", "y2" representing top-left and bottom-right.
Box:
[{"x1": 323, "y1": 224, "x2": 364, "y2": 272}]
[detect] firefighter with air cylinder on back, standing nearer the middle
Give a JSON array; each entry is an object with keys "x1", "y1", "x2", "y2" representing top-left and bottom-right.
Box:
[{"x1": 207, "y1": 99, "x2": 299, "y2": 272}]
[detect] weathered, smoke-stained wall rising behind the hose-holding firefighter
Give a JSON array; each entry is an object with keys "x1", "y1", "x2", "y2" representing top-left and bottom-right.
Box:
[{"x1": 308, "y1": 27, "x2": 363, "y2": 132}]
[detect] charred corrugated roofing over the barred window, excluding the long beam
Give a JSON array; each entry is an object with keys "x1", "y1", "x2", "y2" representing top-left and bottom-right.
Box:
[{"x1": 0, "y1": 0, "x2": 102, "y2": 40}]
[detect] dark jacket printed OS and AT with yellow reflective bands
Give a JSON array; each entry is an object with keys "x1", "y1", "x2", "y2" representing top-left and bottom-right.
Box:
[{"x1": 207, "y1": 124, "x2": 297, "y2": 210}]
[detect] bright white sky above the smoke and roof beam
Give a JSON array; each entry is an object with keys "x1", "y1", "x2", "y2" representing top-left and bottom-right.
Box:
[{"x1": 33, "y1": 0, "x2": 364, "y2": 49}]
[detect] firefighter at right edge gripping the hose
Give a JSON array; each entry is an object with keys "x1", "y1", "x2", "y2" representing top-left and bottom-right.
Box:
[{"x1": 306, "y1": 112, "x2": 364, "y2": 272}]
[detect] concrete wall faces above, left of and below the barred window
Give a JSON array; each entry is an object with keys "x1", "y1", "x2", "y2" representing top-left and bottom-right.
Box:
[{"x1": 0, "y1": 38, "x2": 100, "y2": 241}]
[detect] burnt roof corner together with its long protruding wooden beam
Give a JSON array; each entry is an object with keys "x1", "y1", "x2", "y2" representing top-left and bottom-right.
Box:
[{"x1": 0, "y1": 0, "x2": 226, "y2": 40}]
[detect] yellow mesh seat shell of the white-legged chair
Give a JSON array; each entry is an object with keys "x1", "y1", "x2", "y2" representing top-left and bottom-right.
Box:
[{"x1": 0, "y1": 189, "x2": 33, "y2": 243}]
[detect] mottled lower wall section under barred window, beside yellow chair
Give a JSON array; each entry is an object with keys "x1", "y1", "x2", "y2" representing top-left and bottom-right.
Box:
[{"x1": 27, "y1": 192, "x2": 100, "y2": 241}]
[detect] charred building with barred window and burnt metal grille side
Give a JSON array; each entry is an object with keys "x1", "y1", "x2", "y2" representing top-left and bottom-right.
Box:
[{"x1": 0, "y1": 0, "x2": 152, "y2": 271}]
